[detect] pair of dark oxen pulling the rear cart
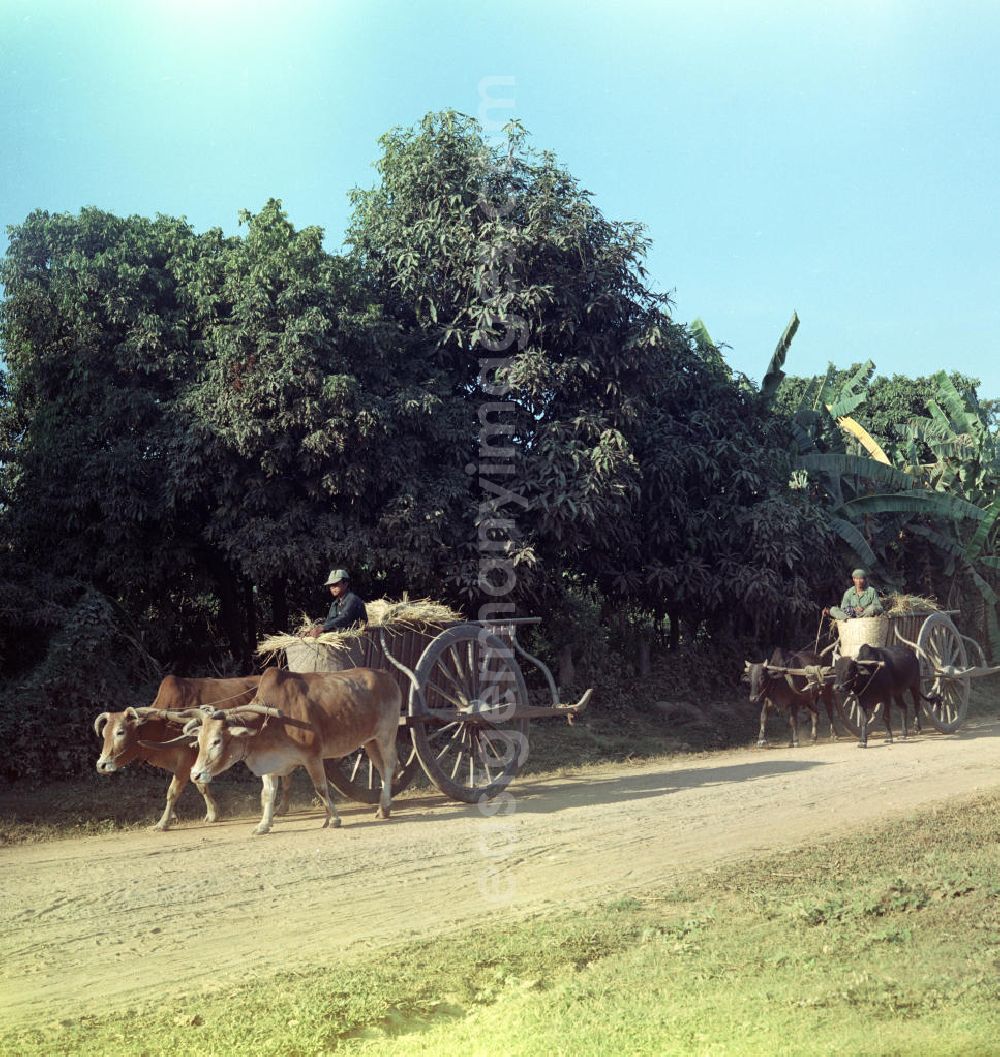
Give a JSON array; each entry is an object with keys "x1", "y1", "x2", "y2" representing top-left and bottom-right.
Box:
[{"x1": 743, "y1": 645, "x2": 941, "y2": 748}]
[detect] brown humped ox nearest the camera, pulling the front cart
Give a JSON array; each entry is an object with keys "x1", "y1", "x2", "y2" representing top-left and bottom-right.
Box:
[{"x1": 144, "y1": 668, "x2": 402, "y2": 833}]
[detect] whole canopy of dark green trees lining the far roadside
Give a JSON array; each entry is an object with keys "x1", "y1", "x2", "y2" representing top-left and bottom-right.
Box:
[{"x1": 0, "y1": 111, "x2": 996, "y2": 710}]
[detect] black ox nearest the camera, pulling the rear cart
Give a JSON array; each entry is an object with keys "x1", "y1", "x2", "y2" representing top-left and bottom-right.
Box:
[{"x1": 834, "y1": 645, "x2": 941, "y2": 748}]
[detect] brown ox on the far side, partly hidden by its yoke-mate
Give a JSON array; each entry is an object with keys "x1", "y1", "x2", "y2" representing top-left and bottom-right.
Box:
[{"x1": 94, "y1": 675, "x2": 288, "y2": 830}]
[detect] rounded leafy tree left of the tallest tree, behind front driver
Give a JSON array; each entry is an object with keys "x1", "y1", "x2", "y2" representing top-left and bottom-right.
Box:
[{"x1": 177, "y1": 201, "x2": 467, "y2": 627}]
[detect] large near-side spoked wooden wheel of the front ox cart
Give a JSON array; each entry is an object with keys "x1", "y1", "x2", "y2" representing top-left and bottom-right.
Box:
[{"x1": 410, "y1": 624, "x2": 527, "y2": 803}]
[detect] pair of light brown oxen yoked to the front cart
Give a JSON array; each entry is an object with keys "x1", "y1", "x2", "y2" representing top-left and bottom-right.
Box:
[{"x1": 94, "y1": 668, "x2": 402, "y2": 833}]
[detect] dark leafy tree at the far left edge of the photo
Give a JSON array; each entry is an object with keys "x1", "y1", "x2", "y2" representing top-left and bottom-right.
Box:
[{"x1": 0, "y1": 209, "x2": 215, "y2": 659}]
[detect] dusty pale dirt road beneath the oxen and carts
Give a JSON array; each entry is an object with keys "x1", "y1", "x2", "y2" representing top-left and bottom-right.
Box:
[{"x1": 0, "y1": 721, "x2": 1000, "y2": 1026}]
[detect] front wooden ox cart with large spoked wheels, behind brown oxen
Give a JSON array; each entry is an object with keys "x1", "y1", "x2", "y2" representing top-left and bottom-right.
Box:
[{"x1": 284, "y1": 616, "x2": 593, "y2": 803}]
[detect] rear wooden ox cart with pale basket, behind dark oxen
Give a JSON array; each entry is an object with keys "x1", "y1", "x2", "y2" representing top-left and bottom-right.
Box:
[{"x1": 773, "y1": 609, "x2": 1000, "y2": 736}]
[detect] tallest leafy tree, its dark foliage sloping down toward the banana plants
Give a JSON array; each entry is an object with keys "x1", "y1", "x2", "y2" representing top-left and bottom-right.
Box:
[{"x1": 350, "y1": 112, "x2": 826, "y2": 627}]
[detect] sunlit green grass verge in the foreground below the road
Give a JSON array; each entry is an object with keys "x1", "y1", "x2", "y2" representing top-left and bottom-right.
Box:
[{"x1": 0, "y1": 796, "x2": 1000, "y2": 1057}]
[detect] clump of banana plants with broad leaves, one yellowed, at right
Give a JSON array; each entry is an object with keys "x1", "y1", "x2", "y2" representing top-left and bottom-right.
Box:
[{"x1": 735, "y1": 313, "x2": 1000, "y2": 657}]
